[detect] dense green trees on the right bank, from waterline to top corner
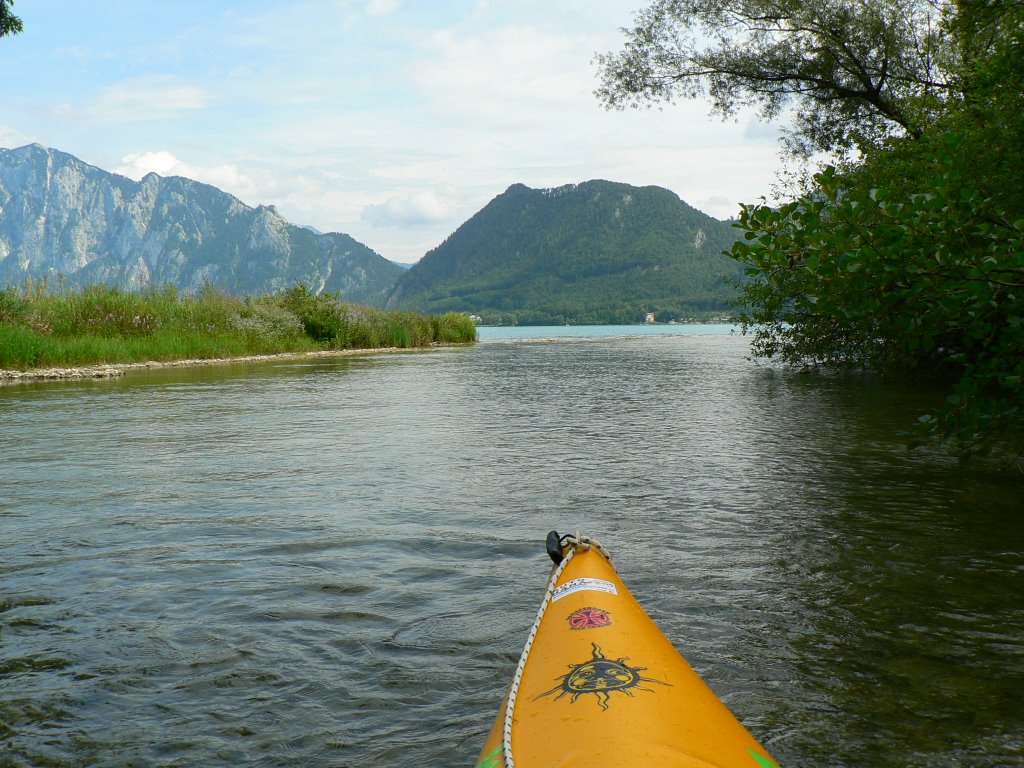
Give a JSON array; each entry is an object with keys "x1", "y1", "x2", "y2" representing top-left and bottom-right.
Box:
[{"x1": 598, "y1": 0, "x2": 1024, "y2": 456}]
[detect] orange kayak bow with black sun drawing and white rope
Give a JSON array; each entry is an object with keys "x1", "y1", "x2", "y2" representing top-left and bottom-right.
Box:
[{"x1": 475, "y1": 531, "x2": 778, "y2": 768}]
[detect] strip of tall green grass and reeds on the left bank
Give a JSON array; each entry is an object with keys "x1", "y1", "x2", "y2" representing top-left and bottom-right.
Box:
[{"x1": 0, "y1": 284, "x2": 476, "y2": 371}]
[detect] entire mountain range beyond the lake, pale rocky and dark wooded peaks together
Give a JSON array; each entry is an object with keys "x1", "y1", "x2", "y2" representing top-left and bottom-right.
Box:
[{"x1": 0, "y1": 144, "x2": 742, "y2": 324}]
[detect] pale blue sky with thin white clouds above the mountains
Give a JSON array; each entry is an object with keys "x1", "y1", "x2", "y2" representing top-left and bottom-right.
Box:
[{"x1": 0, "y1": 0, "x2": 779, "y2": 262}]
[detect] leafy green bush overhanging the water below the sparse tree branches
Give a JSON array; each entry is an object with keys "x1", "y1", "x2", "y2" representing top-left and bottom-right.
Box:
[{"x1": 732, "y1": 158, "x2": 1024, "y2": 453}]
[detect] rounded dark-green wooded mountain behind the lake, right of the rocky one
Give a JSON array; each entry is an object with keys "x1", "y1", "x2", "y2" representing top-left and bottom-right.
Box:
[{"x1": 388, "y1": 180, "x2": 743, "y2": 325}]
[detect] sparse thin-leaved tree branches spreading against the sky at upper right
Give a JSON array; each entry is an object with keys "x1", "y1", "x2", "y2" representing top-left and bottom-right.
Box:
[{"x1": 597, "y1": 0, "x2": 951, "y2": 155}]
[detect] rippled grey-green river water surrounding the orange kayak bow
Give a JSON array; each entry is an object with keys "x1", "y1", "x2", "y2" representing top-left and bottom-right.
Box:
[{"x1": 0, "y1": 327, "x2": 1024, "y2": 768}]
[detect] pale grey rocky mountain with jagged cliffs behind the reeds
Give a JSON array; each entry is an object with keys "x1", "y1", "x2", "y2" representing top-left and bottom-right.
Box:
[{"x1": 0, "y1": 144, "x2": 403, "y2": 304}]
